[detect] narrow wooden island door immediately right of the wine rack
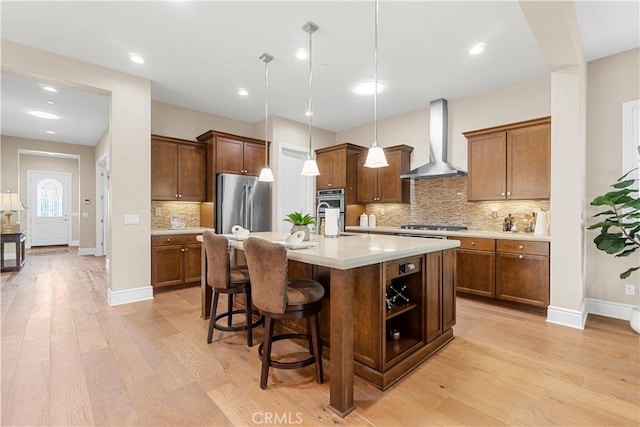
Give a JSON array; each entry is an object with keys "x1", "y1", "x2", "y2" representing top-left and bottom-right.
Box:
[{"x1": 425, "y1": 252, "x2": 443, "y2": 342}]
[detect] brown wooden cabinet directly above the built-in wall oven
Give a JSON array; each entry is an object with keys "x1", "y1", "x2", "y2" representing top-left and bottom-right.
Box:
[{"x1": 316, "y1": 143, "x2": 366, "y2": 205}]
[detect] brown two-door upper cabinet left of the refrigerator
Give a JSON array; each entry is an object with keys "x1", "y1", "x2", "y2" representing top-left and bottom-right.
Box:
[{"x1": 151, "y1": 135, "x2": 207, "y2": 202}]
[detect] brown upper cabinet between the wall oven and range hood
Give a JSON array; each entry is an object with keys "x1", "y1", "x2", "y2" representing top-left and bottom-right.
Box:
[{"x1": 356, "y1": 145, "x2": 413, "y2": 203}]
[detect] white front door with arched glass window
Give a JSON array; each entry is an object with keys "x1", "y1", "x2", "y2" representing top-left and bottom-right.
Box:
[{"x1": 27, "y1": 171, "x2": 71, "y2": 246}]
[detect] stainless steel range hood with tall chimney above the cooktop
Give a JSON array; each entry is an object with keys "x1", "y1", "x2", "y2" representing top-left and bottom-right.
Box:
[{"x1": 400, "y1": 98, "x2": 467, "y2": 179}]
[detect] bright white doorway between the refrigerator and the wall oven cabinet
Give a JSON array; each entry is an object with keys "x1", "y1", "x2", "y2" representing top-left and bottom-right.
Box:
[{"x1": 274, "y1": 143, "x2": 315, "y2": 232}]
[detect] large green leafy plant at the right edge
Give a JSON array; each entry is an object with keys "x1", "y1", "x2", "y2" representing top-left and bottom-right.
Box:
[{"x1": 589, "y1": 146, "x2": 640, "y2": 279}]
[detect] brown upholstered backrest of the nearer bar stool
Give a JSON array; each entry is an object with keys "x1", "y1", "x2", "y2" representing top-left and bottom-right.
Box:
[{"x1": 242, "y1": 237, "x2": 287, "y2": 314}]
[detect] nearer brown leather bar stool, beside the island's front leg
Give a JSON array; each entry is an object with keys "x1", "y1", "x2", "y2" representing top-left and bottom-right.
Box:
[{"x1": 243, "y1": 237, "x2": 324, "y2": 389}]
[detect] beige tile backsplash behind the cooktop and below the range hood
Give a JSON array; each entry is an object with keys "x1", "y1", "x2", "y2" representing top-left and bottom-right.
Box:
[{"x1": 367, "y1": 177, "x2": 550, "y2": 231}]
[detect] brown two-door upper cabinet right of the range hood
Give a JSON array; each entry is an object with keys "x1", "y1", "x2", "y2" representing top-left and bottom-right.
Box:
[{"x1": 464, "y1": 117, "x2": 551, "y2": 201}]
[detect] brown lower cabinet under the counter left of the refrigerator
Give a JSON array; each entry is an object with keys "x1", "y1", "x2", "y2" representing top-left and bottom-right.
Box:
[{"x1": 151, "y1": 234, "x2": 202, "y2": 288}]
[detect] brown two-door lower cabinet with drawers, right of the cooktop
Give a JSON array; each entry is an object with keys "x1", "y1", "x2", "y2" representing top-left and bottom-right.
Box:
[{"x1": 455, "y1": 237, "x2": 549, "y2": 309}]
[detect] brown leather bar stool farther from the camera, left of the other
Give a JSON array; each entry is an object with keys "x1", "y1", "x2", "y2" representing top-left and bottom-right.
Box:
[{"x1": 202, "y1": 230, "x2": 264, "y2": 347}]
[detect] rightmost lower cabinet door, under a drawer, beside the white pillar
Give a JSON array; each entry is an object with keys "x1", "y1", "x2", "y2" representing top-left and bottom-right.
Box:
[{"x1": 496, "y1": 252, "x2": 549, "y2": 307}]
